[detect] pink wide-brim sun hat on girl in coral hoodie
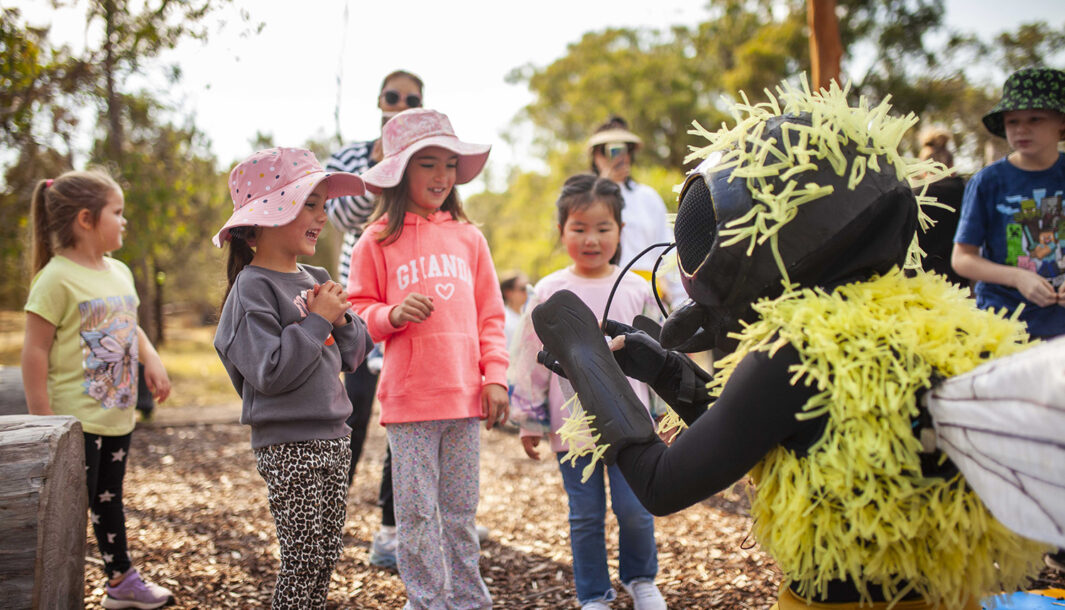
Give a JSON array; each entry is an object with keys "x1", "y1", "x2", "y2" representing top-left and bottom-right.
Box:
[{"x1": 360, "y1": 108, "x2": 492, "y2": 194}]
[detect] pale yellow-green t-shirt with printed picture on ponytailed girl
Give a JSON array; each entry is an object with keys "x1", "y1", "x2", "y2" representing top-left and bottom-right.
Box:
[{"x1": 26, "y1": 255, "x2": 140, "y2": 436}]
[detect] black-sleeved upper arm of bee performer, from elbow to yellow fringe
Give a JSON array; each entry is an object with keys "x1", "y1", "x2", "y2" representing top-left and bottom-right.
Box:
[{"x1": 617, "y1": 346, "x2": 823, "y2": 515}]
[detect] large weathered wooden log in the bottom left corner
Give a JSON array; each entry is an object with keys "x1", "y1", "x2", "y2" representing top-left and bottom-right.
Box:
[{"x1": 0, "y1": 415, "x2": 87, "y2": 608}]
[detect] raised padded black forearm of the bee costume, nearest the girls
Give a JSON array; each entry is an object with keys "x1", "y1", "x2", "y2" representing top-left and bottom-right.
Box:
[{"x1": 531, "y1": 291, "x2": 658, "y2": 464}]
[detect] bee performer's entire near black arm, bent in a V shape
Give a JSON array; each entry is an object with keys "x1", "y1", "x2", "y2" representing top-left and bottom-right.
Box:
[{"x1": 531, "y1": 291, "x2": 822, "y2": 504}]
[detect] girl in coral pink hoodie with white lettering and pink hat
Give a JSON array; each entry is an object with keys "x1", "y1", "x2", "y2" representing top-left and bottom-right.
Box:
[{"x1": 347, "y1": 109, "x2": 508, "y2": 609}]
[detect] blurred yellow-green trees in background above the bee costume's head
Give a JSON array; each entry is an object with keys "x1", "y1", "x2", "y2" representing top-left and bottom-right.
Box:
[{"x1": 492, "y1": 0, "x2": 1065, "y2": 285}]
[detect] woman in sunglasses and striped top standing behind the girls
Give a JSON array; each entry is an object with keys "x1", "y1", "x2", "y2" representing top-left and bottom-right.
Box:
[{"x1": 326, "y1": 70, "x2": 423, "y2": 567}]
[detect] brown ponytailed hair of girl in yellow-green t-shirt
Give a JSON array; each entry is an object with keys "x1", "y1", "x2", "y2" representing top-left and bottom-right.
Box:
[{"x1": 30, "y1": 167, "x2": 121, "y2": 275}]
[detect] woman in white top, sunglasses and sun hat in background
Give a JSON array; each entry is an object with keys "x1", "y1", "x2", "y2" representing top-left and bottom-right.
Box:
[{"x1": 588, "y1": 116, "x2": 683, "y2": 301}]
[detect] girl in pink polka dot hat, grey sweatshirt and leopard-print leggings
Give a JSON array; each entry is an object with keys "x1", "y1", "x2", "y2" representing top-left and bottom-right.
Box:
[{"x1": 214, "y1": 148, "x2": 373, "y2": 608}]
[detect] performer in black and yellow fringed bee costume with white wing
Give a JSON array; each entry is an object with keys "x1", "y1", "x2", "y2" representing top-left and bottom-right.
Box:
[{"x1": 533, "y1": 84, "x2": 1065, "y2": 610}]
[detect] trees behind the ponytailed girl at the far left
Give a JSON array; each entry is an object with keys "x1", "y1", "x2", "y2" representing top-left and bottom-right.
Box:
[{"x1": 0, "y1": 0, "x2": 247, "y2": 340}]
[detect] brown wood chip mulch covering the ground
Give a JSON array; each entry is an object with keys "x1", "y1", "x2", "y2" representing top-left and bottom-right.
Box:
[{"x1": 85, "y1": 409, "x2": 1065, "y2": 609}]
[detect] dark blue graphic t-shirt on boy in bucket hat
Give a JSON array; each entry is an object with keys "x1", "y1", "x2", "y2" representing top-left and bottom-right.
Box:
[{"x1": 954, "y1": 154, "x2": 1065, "y2": 336}]
